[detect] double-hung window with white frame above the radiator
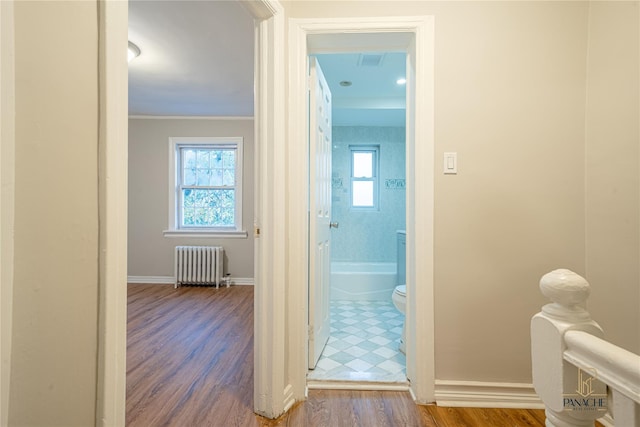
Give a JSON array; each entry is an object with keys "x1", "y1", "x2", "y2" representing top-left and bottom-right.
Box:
[{"x1": 164, "y1": 138, "x2": 246, "y2": 237}]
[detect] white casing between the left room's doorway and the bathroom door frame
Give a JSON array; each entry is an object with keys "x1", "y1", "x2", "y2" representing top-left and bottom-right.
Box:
[{"x1": 239, "y1": 0, "x2": 288, "y2": 418}]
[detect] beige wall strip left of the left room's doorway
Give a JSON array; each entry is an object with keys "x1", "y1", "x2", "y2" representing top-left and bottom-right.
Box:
[{"x1": 8, "y1": 1, "x2": 99, "y2": 426}]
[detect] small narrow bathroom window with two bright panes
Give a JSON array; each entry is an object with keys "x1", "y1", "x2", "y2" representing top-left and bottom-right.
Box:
[{"x1": 349, "y1": 145, "x2": 380, "y2": 210}]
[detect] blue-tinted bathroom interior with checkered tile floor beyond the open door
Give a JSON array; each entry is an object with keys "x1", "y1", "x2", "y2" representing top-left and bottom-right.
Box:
[{"x1": 308, "y1": 53, "x2": 406, "y2": 386}]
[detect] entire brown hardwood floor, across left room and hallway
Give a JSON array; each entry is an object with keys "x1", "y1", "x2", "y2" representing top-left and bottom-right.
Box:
[{"x1": 126, "y1": 284, "x2": 596, "y2": 427}]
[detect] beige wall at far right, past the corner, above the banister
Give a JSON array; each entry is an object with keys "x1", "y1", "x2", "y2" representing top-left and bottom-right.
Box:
[{"x1": 586, "y1": 2, "x2": 640, "y2": 354}]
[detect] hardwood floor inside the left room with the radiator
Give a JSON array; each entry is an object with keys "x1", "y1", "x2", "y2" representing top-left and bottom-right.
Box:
[{"x1": 126, "y1": 285, "x2": 256, "y2": 427}]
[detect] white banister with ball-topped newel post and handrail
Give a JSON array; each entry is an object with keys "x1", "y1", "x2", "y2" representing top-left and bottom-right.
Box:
[{"x1": 531, "y1": 269, "x2": 640, "y2": 427}]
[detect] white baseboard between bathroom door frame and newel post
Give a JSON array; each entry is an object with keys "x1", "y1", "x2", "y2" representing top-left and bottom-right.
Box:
[{"x1": 436, "y1": 380, "x2": 544, "y2": 409}]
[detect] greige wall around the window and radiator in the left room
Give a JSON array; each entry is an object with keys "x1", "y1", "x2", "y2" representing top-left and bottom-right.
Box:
[{"x1": 128, "y1": 118, "x2": 254, "y2": 281}]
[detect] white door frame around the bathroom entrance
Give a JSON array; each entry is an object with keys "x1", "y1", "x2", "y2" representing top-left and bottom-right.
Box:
[{"x1": 286, "y1": 16, "x2": 435, "y2": 404}]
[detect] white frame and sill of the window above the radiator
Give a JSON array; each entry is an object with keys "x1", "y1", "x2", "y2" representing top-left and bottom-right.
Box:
[{"x1": 163, "y1": 137, "x2": 247, "y2": 238}]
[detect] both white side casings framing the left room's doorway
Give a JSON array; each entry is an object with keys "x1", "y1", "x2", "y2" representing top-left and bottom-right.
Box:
[{"x1": 97, "y1": 0, "x2": 284, "y2": 426}]
